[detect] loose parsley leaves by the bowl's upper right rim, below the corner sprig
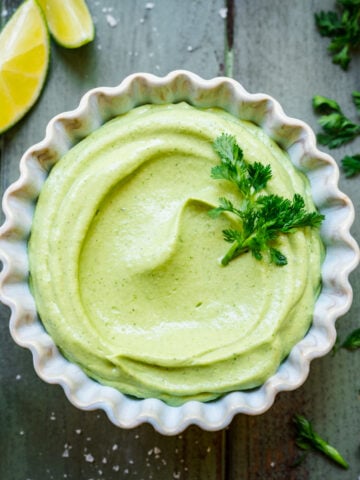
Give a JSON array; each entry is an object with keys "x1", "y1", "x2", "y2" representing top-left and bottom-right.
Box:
[{"x1": 313, "y1": 93, "x2": 360, "y2": 177}]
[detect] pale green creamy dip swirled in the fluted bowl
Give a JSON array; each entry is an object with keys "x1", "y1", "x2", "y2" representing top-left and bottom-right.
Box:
[{"x1": 29, "y1": 103, "x2": 323, "y2": 405}]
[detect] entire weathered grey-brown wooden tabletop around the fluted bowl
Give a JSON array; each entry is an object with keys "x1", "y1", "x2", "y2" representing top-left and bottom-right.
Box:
[{"x1": 0, "y1": 0, "x2": 360, "y2": 480}]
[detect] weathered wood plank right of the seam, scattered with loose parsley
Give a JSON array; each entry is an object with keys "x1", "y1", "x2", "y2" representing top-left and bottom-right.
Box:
[{"x1": 227, "y1": 0, "x2": 360, "y2": 480}]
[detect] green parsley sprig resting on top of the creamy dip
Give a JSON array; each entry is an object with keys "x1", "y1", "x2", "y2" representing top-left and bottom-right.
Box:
[{"x1": 209, "y1": 134, "x2": 324, "y2": 266}]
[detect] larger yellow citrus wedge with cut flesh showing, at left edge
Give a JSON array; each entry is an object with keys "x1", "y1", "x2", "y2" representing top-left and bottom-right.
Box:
[{"x1": 0, "y1": 0, "x2": 50, "y2": 133}]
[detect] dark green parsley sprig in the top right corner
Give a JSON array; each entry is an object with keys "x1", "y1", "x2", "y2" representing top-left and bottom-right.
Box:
[{"x1": 315, "y1": 0, "x2": 360, "y2": 70}]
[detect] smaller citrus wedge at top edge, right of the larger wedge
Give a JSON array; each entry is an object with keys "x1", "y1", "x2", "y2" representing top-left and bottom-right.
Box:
[{"x1": 38, "y1": 0, "x2": 94, "y2": 48}]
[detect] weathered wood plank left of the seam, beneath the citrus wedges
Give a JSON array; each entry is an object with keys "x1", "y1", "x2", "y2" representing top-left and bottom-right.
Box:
[{"x1": 0, "y1": 0, "x2": 228, "y2": 480}]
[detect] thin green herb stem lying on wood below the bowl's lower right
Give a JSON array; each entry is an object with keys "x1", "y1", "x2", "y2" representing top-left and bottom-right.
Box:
[{"x1": 294, "y1": 415, "x2": 349, "y2": 469}]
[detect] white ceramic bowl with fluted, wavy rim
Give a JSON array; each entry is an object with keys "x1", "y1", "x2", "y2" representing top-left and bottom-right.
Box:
[{"x1": 0, "y1": 71, "x2": 359, "y2": 435}]
